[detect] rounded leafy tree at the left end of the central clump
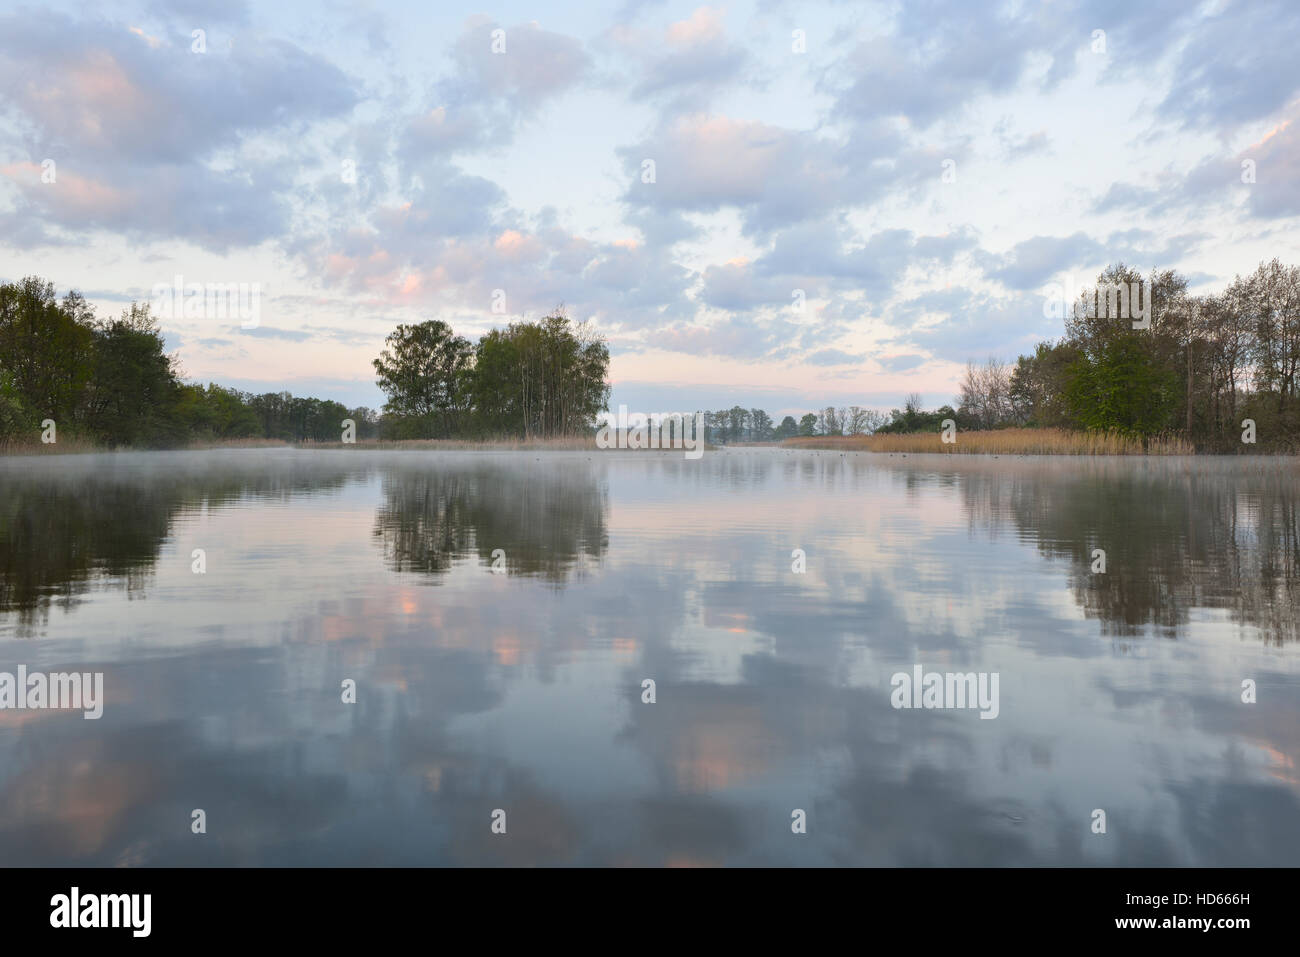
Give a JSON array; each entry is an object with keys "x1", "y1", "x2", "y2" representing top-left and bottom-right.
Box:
[{"x1": 373, "y1": 319, "x2": 473, "y2": 436}]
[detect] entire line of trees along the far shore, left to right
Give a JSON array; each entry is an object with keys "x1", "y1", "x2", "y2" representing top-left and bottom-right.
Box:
[{"x1": 12, "y1": 259, "x2": 1300, "y2": 451}]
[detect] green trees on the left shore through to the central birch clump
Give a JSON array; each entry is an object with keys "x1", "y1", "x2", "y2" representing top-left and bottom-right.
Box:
[{"x1": 0, "y1": 277, "x2": 608, "y2": 447}]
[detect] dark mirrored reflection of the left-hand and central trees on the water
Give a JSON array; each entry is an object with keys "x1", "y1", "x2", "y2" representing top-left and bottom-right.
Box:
[{"x1": 0, "y1": 451, "x2": 607, "y2": 636}]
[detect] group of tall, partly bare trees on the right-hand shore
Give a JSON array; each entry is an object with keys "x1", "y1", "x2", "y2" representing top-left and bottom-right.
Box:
[{"x1": 941, "y1": 259, "x2": 1300, "y2": 451}]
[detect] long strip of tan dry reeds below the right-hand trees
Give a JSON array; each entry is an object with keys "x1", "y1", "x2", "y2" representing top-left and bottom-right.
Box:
[{"x1": 781, "y1": 429, "x2": 1196, "y2": 455}]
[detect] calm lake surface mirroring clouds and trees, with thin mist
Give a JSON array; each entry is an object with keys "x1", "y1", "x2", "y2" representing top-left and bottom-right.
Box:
[{"x1": 0, "y1": 449, "x2": 1300, "y2": 866}]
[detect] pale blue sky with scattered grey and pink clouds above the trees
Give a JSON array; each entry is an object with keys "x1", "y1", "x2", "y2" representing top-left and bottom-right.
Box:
[{"x1": 0, "y1": 0, "x2": 1300, "y2": 415}]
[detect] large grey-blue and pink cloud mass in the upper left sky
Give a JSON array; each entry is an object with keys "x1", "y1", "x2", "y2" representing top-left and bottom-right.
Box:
[{"x1": 0, "y1": 14, "x2": 359, "y2": 250}]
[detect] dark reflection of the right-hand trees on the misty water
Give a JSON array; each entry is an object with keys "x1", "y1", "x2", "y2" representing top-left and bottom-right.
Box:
[{"x1": 907, "y1": 459, "x2": 1300, "y2": 644}]
